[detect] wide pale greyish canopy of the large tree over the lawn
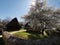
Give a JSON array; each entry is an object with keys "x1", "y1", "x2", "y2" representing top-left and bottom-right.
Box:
[{"x1": 23, "y1": 0, "x2": 60, "y2": 32}]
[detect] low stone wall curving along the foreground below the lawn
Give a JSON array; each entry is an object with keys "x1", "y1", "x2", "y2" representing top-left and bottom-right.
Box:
[{"x1": 2, "y1": 31, "x2": 60, "y2": 45}]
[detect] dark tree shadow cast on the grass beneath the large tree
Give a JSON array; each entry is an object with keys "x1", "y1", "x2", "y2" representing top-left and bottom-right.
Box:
[{"x1": 28, "y1": 31, "x2": 46, "y2": 40}]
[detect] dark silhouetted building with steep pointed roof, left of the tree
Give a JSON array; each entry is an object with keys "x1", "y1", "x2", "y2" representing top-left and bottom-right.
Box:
[{"x1": 6, "y1": 18, "x2": 21, "y2": 31}]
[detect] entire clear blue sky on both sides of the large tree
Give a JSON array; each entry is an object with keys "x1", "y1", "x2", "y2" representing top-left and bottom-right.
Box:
[{"x1": 0, "y1": 0, "x2": 60, "y2": 20}]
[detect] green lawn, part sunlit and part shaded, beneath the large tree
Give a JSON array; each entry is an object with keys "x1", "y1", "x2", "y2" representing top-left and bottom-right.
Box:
[{"x1": 14, "y1": 29, "x2": 47, "y2": 39}]
